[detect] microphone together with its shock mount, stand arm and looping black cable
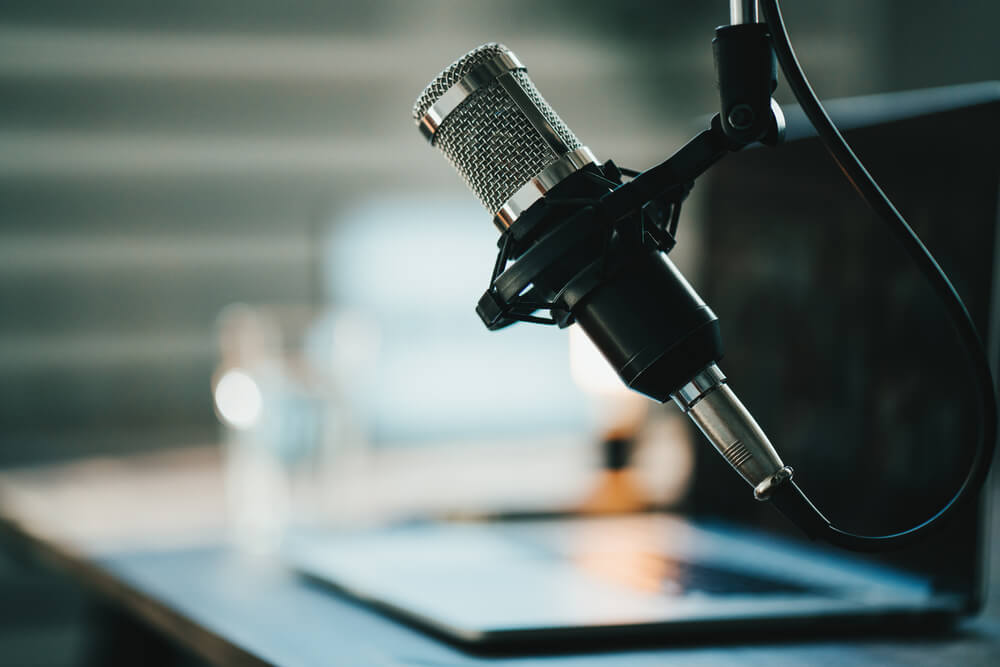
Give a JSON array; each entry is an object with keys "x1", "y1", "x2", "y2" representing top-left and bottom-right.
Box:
[{"x1": 413, "y1": 0, "x2": 997, "y2": 551}]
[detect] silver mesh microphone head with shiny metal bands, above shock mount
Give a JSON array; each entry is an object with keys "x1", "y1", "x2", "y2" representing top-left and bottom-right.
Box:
[{"x1": 413, "y1": 43, "x2": 597, "y2": 230}]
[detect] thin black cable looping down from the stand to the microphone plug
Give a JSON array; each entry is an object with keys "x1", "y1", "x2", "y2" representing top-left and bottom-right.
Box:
[{"x1": 760, "y1": 0, "x2": 997, "y2": 552}]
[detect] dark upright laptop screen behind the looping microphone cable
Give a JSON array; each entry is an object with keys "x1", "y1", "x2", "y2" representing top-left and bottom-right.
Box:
[{"x1": 696, "y1": 84, "x2": 1000, "y2": 604}]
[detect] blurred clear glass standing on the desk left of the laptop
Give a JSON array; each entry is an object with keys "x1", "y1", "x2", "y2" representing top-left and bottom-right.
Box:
[{"x1": 213, "y1": 305, "x2": 363, "y2": 551}]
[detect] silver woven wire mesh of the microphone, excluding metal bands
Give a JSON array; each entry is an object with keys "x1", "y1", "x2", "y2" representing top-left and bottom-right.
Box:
[{"x1": 414, "y1": 44, "x2": 583, "y2": 213}]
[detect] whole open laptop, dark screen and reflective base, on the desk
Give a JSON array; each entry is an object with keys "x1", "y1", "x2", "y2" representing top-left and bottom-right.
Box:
[{"x1": 284, "y1": 83, "x2": 1000, "y2": 649}]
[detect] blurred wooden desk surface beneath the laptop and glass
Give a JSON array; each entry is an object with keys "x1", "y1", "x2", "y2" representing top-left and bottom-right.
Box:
[{"x1": 0, "y1": 448, "x2": 1000, "y2": 667}]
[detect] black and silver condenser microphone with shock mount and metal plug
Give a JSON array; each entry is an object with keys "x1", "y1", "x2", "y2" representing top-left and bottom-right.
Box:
[{"x1": 413, "y1": 44, "x2": 792, "y2": 508}]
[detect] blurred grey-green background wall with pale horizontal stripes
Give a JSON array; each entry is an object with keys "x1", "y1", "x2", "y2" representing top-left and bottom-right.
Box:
[{"x1": 0, "y1": 0, "x2": 1000, "y2": 464}]
